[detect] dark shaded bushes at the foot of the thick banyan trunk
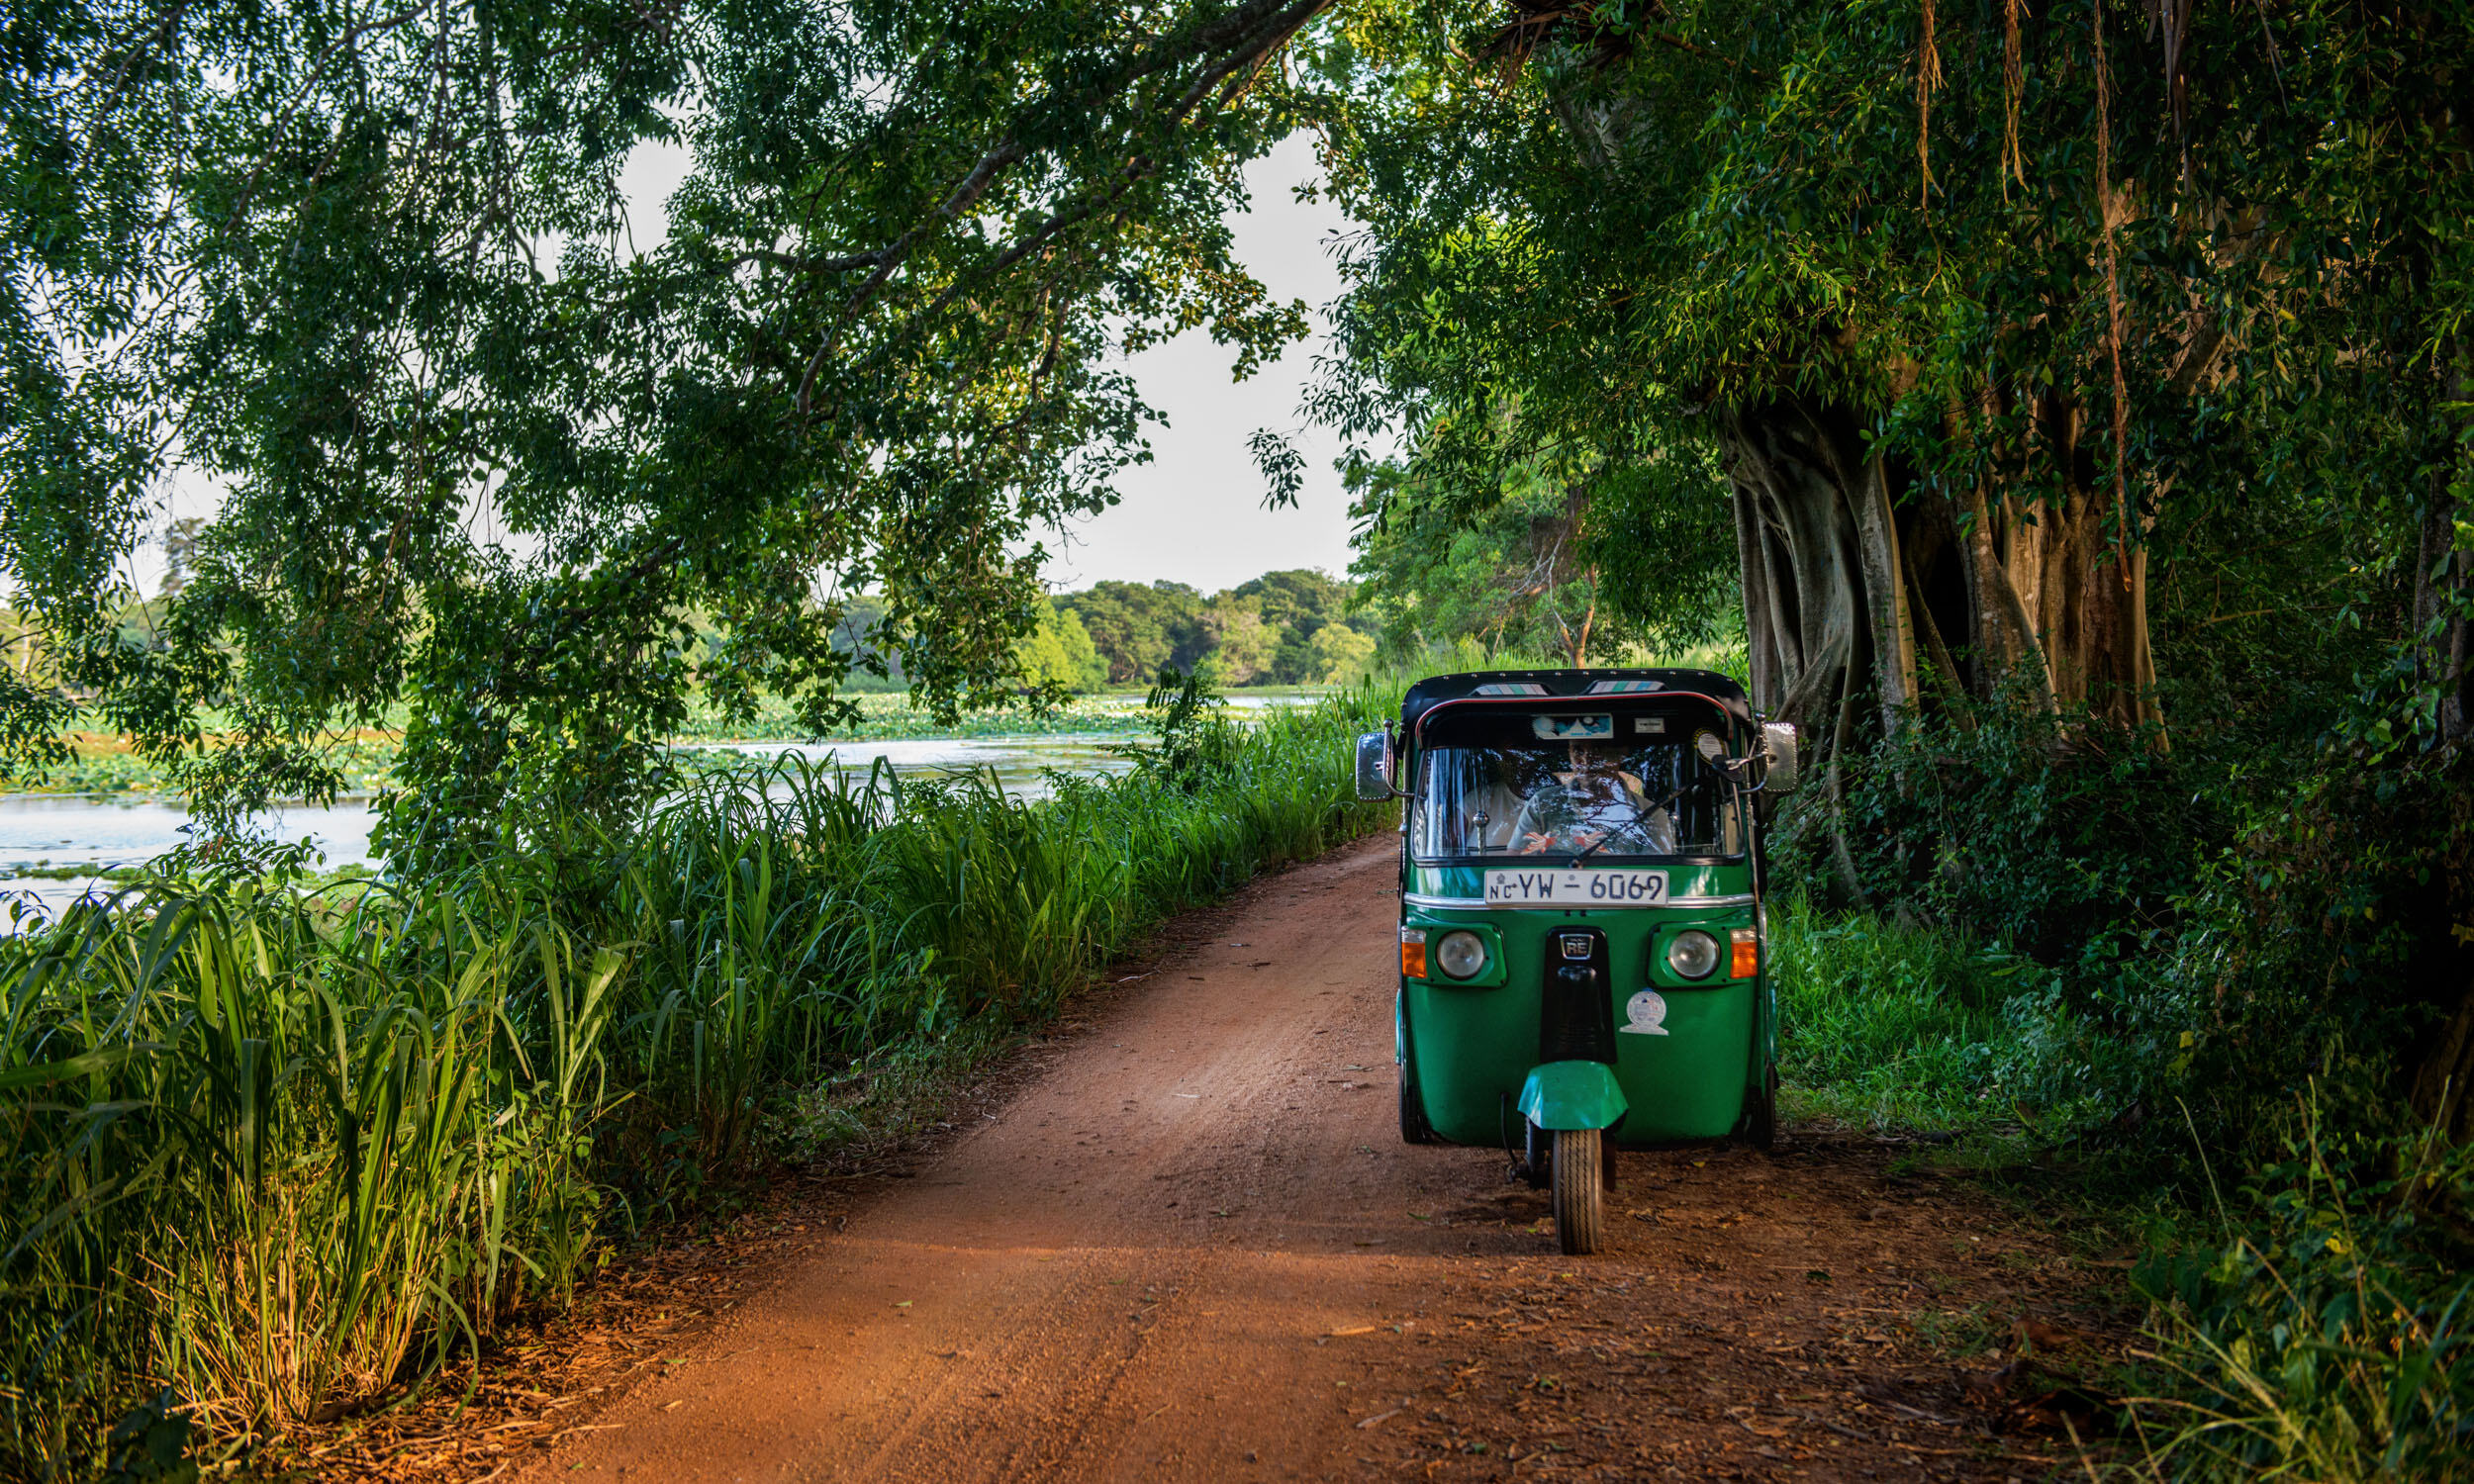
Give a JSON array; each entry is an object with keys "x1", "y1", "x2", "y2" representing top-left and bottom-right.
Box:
[{"x1": 1774, "y1": 678, "x2": 2474, "y2": 1156}]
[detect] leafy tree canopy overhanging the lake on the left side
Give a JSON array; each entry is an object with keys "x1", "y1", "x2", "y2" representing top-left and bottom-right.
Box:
[{"x1": 0, "y1": 0, "x2": 1319, "y2": 864}]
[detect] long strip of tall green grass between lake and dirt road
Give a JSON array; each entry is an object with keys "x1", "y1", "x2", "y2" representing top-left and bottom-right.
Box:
[{"x1": 0, "y1": 693, "x2": 1393, "y2": 1479}]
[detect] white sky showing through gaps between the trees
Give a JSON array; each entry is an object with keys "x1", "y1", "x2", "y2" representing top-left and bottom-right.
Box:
[{"x1": 129, "y1": 134, "x2": 1351, "y2": 594}]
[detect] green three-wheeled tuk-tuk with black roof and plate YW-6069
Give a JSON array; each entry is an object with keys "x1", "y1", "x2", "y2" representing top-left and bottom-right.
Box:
[{"x1": 1359, "y1": 671, "x2": 1796, "y2": 1254}]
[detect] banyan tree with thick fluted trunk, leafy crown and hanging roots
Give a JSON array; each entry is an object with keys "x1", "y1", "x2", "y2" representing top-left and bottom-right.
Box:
[{"x1": 1329, "y1": 0, "x2": 2467, "y2": 747}]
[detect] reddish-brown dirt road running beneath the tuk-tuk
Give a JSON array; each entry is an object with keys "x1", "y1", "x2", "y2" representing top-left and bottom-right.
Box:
[{"x1": 529, "y1": 839, "x2": 2086, "y2": 1484}]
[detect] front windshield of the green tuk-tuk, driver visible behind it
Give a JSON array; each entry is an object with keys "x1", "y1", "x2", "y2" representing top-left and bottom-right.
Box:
[{"x1": 1410, "y1": 737, "x2": 1745, "y2": 861}]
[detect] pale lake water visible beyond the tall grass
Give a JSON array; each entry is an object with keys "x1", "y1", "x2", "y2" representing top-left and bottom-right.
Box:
[{"x1": 0, "y1": 735, "x2": 1136, "y2": 910}]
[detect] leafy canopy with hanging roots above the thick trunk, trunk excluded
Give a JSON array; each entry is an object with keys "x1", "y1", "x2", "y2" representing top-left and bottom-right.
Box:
[{"x1": 1301, "y1": 0, "x2": 2474, "y2": 742}]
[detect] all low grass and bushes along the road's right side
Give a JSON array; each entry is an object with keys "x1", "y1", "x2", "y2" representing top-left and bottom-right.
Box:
[{"x1": 1774, "y1": 710, "x2": 2474, "y2": 1482}]
